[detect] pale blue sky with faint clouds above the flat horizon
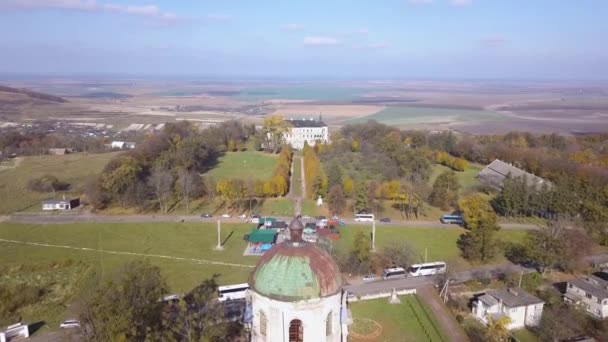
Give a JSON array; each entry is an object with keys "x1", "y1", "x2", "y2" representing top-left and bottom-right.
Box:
[{"x1": 0, "y1": 0, "x2": 608, "y2": 80}]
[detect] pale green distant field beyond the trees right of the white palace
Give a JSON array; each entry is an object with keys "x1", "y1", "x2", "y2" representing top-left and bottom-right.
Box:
[{"x1": 345, "y1": 107, "x2": 502, "y2": 127}]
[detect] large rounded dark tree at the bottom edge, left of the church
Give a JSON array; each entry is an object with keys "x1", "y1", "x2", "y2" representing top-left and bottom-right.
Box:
[{"x1": 80, "y1": 260, "x2": 167, "y2": 341}]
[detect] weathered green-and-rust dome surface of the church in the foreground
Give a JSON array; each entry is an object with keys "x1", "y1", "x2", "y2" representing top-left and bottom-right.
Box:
[{"x1": 249, "y1": 242, "x2": 342, "y2": 301}]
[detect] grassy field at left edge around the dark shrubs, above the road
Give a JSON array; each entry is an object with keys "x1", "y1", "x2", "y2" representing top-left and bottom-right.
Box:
[{"x1": 0, "y1": 152, "x2": 119, "y2": 214}]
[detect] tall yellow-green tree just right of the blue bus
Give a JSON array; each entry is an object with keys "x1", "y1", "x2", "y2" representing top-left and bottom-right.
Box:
[{"x1": 458, "y1": 195, "x2": 500, "y2": 263}]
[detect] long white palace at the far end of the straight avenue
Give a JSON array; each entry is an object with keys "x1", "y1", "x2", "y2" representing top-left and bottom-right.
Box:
[{"x1": 284, "y1": 118, "x2": 329, "y2": 150}]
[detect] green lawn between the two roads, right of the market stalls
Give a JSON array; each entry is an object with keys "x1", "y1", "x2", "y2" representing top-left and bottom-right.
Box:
[{"x1": 334, "y1": 224, "x2": 526, "y2": 269}]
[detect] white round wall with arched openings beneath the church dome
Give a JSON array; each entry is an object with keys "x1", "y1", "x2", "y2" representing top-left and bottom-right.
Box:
[{"x1": 251, "y1": 291, "x2": 342, "y2": 342}]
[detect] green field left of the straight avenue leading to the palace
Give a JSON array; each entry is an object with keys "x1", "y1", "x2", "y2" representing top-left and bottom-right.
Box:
[{"x1": 207, "y1": 151, "x2": 277, "y2": 180}]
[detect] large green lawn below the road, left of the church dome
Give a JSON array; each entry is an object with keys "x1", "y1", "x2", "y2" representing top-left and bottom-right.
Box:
[{"x1": 0, "y1": 223, "x2": 258, "y2": 326}]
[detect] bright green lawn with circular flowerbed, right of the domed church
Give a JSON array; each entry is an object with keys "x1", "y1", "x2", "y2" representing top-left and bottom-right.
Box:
[{"x1": 349, "y1": 295, "x2": 450, "y2": 342}]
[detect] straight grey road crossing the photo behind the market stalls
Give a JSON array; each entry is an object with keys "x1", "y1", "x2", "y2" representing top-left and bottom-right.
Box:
[{"x1": 0, "y1": 213, "x2": 538, "y2": 230}]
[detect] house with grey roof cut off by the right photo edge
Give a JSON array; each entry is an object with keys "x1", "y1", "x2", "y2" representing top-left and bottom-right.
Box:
[{"x1": 564, "y1": 275, "x2": 608, "y2": 319}]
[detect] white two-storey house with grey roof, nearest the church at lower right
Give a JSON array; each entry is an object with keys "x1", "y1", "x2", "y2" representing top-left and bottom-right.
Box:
[{"x1": 473, "y1": 287, "x2": 545, "y2": 330}]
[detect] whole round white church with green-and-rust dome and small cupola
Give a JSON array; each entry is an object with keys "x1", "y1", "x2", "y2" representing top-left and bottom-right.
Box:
[{"x1": 249, "y1": 219, "x2": 348, "y2": 342}]
